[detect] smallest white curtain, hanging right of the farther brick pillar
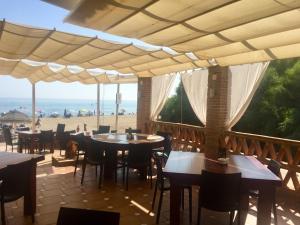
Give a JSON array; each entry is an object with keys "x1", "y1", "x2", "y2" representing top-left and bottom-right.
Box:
[{"x1": 150, "y1": 74, "x2": 176, "y2": 120}]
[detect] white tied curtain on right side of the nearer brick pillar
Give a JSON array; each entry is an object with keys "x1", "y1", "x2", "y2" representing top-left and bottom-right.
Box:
[{"x1": 226, "y1": 62, "x2": 269, "y2": 129}]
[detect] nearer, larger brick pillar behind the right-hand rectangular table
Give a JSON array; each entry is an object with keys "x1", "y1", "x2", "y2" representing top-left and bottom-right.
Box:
[{"x1": 205, "y1": 66, "x2": 231, "y2": 158}]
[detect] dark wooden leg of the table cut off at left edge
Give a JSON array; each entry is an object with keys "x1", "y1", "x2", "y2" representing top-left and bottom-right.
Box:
[{"x1": 24, "y1": 162, "x2": 36, "y2": 215}]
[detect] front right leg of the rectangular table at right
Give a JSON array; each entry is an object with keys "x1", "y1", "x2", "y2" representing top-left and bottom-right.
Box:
[{"x1": 257, "y1": 185, "x2": 275, "y2": 225}]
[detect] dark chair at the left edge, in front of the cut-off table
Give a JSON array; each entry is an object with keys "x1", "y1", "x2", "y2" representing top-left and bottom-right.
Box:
[{"x1": 0, "y1": 161, "x2": 34, "y2": 225}]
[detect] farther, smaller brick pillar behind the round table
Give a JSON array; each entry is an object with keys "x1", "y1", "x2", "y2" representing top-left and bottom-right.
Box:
[{"x1": 136, "y1": 77, "x2": 152, "y2": 132}]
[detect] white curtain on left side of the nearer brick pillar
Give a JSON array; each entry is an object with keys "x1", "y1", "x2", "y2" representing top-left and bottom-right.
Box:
[{"x1": 181, "y1": 70, "x2": 208, "y2": 125}]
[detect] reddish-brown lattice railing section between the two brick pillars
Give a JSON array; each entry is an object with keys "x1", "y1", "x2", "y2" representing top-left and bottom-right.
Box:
[{"x1": 149, "y1": 121, "x2": 205, "y2": 152}]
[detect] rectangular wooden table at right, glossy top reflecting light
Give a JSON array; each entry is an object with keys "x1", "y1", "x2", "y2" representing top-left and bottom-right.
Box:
[{"x1": 164, "y1": 151, "x2": 281, "y2": 225}]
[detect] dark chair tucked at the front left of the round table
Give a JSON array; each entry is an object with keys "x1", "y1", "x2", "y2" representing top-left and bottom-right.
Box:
[{"x1": 81, "y1": 139, "x2": 105, "y2": 188}]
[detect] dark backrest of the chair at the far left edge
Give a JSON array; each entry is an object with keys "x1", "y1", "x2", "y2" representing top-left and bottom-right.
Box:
[{"x1": 1, "y1": 160, "x2": 33, "y2": 201}]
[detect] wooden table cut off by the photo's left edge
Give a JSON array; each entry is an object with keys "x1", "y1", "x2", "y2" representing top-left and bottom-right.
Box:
[{"x1": 0, "y1": 152, "x2": 45, "y2": 215}]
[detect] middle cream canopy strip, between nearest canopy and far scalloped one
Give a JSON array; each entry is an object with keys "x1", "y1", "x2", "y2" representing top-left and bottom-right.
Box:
[{"x1": 0, "y1": 21, "x2": 209, "y2": 76}]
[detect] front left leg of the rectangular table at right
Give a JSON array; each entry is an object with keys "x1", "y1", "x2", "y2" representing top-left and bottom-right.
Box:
[{"x1": 170, "y1": 179, "x2": 181, "y2": 225}]
